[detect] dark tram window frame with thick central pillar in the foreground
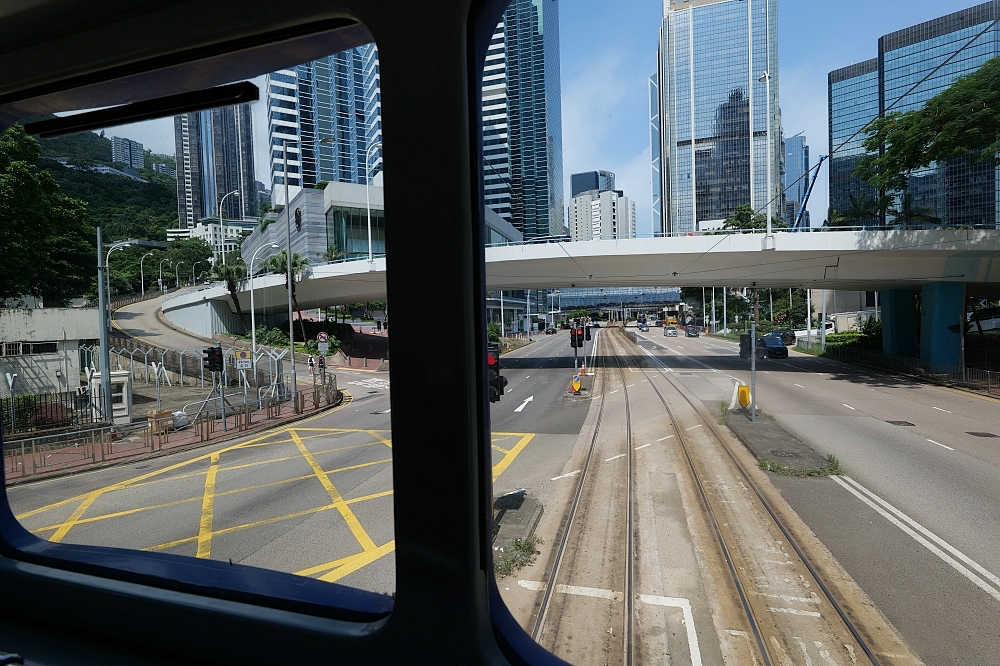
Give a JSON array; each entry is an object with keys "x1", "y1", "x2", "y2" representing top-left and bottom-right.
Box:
[{"x1": 0, "y1": 0, "x2": 562, "y2": 664}]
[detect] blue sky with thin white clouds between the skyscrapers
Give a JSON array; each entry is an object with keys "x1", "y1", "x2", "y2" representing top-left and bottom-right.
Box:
[{"x1": 108, "y1": 0, "x2": 976, "y2": 235}]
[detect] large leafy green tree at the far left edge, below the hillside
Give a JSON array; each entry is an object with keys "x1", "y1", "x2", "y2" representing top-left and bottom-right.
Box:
[{"x1": 0, "y1": 124, "x2": 97, "y2": 304}]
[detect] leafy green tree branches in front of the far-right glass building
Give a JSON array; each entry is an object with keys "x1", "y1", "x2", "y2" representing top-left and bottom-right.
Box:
[{"x1": 854, "y1": 58, "x2": 1000, "y2": 192}]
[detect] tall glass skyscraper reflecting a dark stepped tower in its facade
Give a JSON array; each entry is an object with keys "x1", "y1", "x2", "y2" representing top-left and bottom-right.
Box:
[{"x1": 650, "y1": 0, "x2": 783, "y2": 233}]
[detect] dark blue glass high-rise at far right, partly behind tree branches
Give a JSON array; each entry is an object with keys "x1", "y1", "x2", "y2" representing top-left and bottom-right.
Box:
[{"x1": 829, "y1": 0, "x2": 1000, "y2": 227}]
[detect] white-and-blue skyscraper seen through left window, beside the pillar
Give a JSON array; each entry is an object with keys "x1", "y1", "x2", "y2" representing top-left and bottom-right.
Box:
[{"x1": 267, "y1": 44, "x2": 382, "y2": 207}]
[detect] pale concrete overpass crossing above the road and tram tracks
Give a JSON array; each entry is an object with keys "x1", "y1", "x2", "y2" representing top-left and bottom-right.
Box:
[{"x1": 163, "y1": 229, "x2": 1000, "y2": 363}]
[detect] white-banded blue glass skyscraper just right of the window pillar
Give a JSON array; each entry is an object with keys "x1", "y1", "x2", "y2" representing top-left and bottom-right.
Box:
[{"x1": 483, "y1": 0, "x2": 564, "y2": 238}]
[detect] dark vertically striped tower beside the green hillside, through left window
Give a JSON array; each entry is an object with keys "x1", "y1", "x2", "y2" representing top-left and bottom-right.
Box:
[{"x1": 174, "y1": 104, "x2": 257, "y2": 229}]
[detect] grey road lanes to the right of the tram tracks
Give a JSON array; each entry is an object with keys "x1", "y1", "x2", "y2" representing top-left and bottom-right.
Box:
[{"x1": 641, "y1": 329, "x2": 1000, "y2": 664}]
